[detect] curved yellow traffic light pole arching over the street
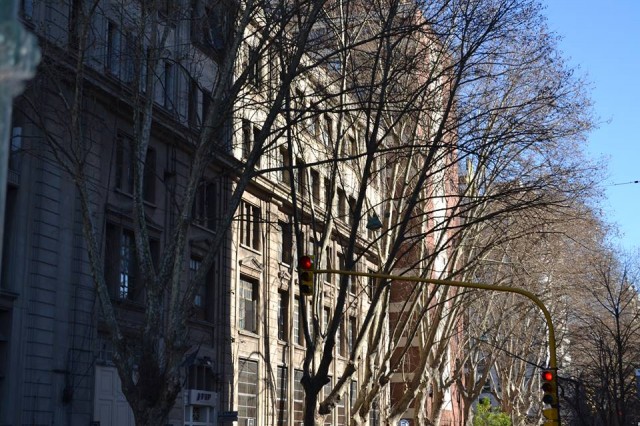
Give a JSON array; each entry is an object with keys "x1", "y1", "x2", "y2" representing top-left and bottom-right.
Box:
[{"x1": 313, "y1": 269, "x2": 560, "y2": 424}]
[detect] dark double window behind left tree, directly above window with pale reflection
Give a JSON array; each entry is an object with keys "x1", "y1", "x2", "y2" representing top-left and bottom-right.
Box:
[{"x1": 115, "y1": 134, "x2": 156, "y2": 203}]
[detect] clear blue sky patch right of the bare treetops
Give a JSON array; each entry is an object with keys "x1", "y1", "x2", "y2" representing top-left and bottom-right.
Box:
[{"x1": 543, "y1": 0, "x2": 640, "y2": 250}]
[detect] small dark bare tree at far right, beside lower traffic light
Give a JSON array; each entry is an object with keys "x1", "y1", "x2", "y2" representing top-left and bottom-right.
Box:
[{"x1": 563, "y1": 251, "x2": 640, "y2": 425}]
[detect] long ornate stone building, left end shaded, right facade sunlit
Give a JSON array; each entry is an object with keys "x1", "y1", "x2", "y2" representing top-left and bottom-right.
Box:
[{"x1": 0, "y1": 0, "x2": 384, "y2": 426}]
